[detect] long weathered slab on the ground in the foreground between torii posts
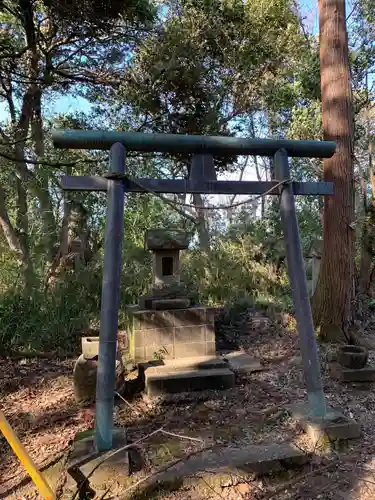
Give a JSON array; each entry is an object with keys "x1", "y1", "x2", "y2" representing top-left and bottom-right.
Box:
[{"x1": 128, "y1": 443, "x2": 309, "y2": 498}]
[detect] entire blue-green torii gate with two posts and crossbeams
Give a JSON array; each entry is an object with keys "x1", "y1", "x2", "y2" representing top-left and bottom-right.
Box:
[{"x1": 52, "y1": 130, "x2": 336, "y2": 451}]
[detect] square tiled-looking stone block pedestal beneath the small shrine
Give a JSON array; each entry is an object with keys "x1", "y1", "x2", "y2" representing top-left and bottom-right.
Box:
[{"x1": 129, "y1": 307, "x2": 216, "y2": 364}]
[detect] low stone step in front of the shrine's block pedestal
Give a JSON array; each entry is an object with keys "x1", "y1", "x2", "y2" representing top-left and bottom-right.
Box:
[{"x1": 141, "y1": 357, "x2": 235, "y2": 396}]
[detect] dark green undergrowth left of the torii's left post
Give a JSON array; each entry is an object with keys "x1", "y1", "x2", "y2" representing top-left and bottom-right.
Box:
[{"x1": 0, "y1": 269, "x2": 100, "y2": 355}]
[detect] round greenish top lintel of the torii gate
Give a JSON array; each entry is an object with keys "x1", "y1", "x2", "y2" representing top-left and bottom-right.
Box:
[{"x1": 52, "y1": 129, "x2": 336, "y2": 158}]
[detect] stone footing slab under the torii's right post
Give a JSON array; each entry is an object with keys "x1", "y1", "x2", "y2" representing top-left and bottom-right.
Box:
[{"x1": 288, "y1": 403, "x2": 360, "y2": 443}]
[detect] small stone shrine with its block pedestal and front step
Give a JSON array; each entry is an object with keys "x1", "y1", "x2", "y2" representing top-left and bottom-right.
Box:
[{"x1": 129, "y1": 229, "x2": 234, "y2": 395}]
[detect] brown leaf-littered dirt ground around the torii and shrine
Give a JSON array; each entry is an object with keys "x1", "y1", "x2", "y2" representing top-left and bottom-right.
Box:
[{"x1": 0, "y1": 322, "x2": 375, "y2": 500}]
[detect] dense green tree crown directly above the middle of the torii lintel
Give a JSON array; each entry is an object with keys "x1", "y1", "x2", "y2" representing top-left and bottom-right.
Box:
[{"x1": 120, "y1": 0, "x2": 300, "y2": 135}]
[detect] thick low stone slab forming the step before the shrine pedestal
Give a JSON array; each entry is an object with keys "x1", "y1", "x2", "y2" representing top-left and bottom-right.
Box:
[{"x1": 145, "y1": 365, "x2": 235, "y2": 396}]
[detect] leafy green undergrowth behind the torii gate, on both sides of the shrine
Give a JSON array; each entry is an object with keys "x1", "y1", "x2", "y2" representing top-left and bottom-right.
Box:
[{"x1": 0, "y1": 236, "x2": 291, "y2": 355}]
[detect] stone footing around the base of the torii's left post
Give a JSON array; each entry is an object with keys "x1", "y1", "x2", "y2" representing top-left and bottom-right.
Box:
[{"x1": 67, "y1": 428, "x2": 129, "y2": 494}]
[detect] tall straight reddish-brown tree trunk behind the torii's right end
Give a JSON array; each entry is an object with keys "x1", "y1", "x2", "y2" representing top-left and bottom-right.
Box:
[{"x1": 313, "y1": 0, "x2": 355, "y2": 340}]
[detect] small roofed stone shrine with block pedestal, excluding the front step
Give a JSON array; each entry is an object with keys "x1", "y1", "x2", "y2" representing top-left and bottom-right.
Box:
[{"x1": 129, "y1": 229, "x2": 216, "y2": 364}]
